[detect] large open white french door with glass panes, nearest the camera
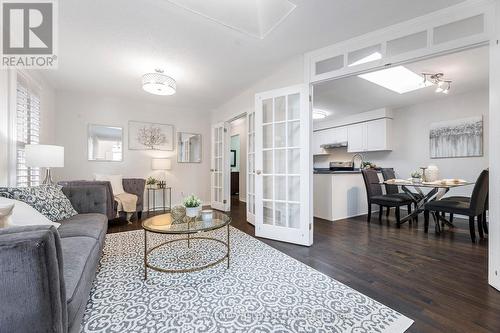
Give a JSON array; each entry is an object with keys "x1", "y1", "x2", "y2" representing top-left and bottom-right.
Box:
[{"x1": 254, "y1": 85, "x2": 313, "y2": 246}]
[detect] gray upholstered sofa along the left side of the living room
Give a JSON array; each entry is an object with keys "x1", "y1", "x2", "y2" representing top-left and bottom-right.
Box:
[{"x1": 0, "y1": 185, "x2": 108, "y2": 333}]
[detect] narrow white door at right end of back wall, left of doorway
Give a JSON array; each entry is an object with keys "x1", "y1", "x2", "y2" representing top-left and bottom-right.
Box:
[{"x1": 210, "y1": 123, "x2": 231, "y2": 211}]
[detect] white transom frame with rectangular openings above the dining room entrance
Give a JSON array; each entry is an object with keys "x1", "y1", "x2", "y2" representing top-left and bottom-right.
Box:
[{"x1": 304, "y1": 0, "x2": 496, "y2": 83}]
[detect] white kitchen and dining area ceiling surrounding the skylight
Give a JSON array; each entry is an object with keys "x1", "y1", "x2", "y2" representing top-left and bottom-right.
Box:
[{"x1": 314, "y1": 46, "x2": 489, "y2": 117}]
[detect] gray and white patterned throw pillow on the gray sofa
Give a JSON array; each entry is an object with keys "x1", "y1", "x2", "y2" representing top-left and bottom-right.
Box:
[{"x1": 9, "y1": 185, "x2": 78, "y2": 222}]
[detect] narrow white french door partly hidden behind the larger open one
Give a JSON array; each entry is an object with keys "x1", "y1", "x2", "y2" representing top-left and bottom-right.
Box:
[{"x1": 247, "y1": 112, "x2": 255, "y2": 225}]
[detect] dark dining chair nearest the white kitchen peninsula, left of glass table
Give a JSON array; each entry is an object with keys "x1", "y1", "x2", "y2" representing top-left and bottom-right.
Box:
[{"x1": 361, "y1": 169, "x2": 413, "y2": 227}]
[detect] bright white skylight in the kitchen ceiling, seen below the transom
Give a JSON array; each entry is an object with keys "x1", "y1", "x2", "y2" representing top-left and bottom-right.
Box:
[{"x1": 358, "y1": 66, "x2": 432, "y2": 94}]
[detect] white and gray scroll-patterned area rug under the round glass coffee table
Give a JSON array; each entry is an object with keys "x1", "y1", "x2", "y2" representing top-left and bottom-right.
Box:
[{"x1": 82, "y1": 227, "x2": 413, "y2": 333}]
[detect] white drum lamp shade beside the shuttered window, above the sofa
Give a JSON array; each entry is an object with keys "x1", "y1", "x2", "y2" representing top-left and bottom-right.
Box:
[{"x1": 24, "y1": 145, "x2": 64, "y2": 168}]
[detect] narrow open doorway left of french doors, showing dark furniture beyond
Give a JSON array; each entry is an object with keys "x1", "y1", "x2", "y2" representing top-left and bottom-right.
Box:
[{"x1": 229, "y1": 114, "x2": 247, "y2": 205}]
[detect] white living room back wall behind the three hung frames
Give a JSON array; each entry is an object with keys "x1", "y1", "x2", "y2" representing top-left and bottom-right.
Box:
[{"x1": 55, "y1": 91, "x2": 210, "y2": 204}]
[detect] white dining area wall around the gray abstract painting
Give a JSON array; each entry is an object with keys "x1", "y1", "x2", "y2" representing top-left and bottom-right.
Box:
[{"x1": 314, "y1": 89, "x2": 489, "y2": 195}]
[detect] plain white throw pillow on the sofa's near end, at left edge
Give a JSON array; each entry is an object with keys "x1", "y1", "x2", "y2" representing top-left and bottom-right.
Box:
[{"x1": 0, "y1": 197, "x2": 61, "y2": 228}]
